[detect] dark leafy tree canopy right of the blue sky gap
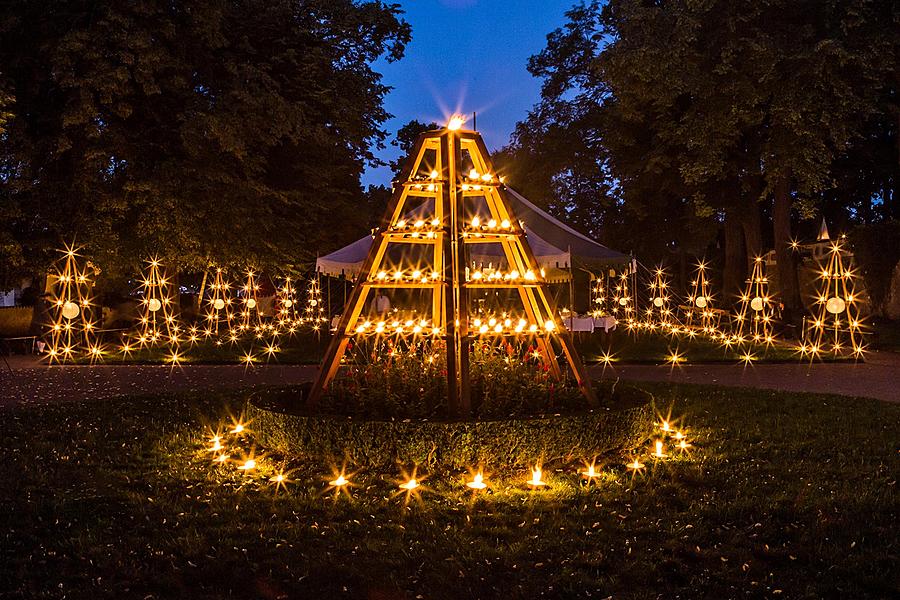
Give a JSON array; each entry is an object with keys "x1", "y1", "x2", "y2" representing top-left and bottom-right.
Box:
[{"x1": 504, "y1": 0, "x2": 900, "y2": 310}]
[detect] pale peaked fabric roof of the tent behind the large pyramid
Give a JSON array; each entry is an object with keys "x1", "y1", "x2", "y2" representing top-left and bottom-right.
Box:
[{"x1": 316, "y1": 187, "x2": 631, "y2": 279}]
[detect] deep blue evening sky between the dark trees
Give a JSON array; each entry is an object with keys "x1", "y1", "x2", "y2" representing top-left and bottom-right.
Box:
[{"x1": 362, "y1": 0, "x2": 576, "y2": 187}]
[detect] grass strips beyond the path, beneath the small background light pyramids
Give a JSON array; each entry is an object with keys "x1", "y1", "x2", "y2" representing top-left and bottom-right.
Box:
[{"x1": 81, "y1": 331, "x2": 816, "y2": 364}]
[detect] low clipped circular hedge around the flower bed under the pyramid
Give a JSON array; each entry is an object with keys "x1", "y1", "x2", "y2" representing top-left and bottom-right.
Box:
[{"x1": 247, "y1": 386, "x2": 653, "y2": 468}]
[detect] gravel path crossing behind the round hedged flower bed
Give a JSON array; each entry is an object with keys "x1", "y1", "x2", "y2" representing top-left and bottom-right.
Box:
[{"x1": 0, "y1": 352, "x2": 900, "y2": 407}]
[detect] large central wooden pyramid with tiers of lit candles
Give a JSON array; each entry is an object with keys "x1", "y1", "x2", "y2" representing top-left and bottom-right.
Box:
[{"x1": 307, "y1": 117, "x2": 595, "y2": 415}]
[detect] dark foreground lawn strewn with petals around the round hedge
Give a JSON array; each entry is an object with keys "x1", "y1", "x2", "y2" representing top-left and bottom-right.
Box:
[{"x1": 0, "y1": 384, "x2": 900, "y2": 599}]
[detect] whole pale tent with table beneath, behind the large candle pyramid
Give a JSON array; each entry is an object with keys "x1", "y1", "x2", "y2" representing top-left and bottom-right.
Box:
[{"x1": 316, "y1": 187, "x2": 636, "y2": 331}]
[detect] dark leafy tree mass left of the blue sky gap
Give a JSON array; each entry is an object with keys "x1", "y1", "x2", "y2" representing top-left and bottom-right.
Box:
[{"x1": 0, "y1": 0, "x2": 410, "y2": 288}]
